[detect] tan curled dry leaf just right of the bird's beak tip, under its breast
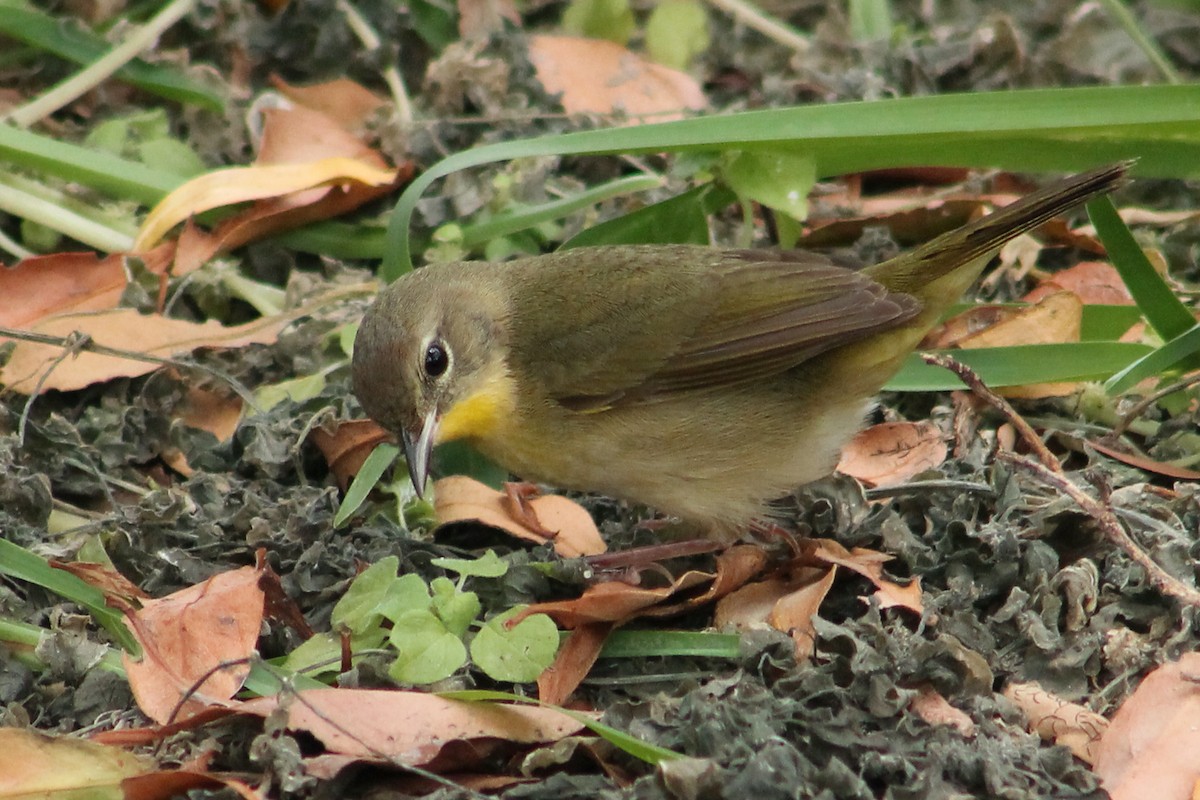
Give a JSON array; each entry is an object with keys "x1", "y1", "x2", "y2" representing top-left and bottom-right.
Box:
[{"x1": 433, "y1": 475, "x2": 607, "y2": 558}]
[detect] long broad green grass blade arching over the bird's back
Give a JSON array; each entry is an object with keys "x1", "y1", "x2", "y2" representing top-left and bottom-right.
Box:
[{"x1": 382, "y1": 84, "x2": 1200, "y2": 281}]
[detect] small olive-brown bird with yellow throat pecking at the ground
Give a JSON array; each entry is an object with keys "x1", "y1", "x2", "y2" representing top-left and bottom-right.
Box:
[{"x1": 352, "y1": 163, "x2": 1129, "y2": 540}]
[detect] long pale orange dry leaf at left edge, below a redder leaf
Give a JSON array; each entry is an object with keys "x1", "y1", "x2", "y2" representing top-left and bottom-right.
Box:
[{"x1": 0, "y1": 308, "x2": 300, "y2": 395}]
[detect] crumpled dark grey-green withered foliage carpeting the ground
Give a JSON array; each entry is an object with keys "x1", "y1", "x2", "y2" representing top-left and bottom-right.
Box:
[{"x1": 0, "y1": 1, "x2": 1200, "y2": 799}]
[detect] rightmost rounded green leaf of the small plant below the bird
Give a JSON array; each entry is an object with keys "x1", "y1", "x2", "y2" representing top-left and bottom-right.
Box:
[{"x1": 470, "y1": 608, "x2": 558, "y2": 684}]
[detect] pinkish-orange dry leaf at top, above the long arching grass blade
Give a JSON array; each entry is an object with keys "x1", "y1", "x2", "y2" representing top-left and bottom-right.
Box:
[{"x1": 529, "y1": 36, "x2": 708, "y2": 122}]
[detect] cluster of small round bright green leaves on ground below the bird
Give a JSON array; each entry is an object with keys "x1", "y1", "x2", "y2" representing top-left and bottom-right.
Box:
[{"x1": 283, "y1": 551, "x2": 559, "y2": 684}]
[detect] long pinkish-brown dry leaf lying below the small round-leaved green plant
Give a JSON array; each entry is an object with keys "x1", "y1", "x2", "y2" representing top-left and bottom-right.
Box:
[{"x1": 240, "y1": 688, "x2": 583, "y2": 766}]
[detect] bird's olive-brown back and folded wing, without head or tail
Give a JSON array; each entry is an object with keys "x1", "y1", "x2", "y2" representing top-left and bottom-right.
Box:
[{"x1": 514, "y1": 246, "x2": 919, "y2": 410}]
